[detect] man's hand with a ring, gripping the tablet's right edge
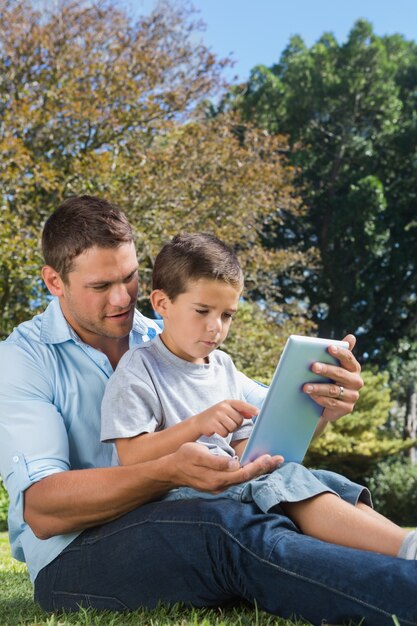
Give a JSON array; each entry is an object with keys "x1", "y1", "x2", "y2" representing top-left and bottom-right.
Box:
[{"x1": 303, "y1": 335, "x2": 363, "y2": 434}]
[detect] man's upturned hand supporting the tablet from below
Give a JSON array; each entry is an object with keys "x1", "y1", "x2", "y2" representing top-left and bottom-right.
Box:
[{"x1": 171, "y1": 443, "x2": 284, "y2": 493}]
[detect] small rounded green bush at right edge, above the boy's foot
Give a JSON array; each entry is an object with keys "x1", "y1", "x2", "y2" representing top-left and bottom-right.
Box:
[{"x1": 367, "y1": 459, "x2": 417, "y2": 526}]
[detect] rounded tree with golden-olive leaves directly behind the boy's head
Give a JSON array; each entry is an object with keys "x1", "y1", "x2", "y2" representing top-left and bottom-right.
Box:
[{"x1": 109, "y1": 115, "x2": 305, "y2": 316}]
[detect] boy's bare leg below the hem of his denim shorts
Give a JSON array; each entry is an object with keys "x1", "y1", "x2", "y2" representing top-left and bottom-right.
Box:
[{"x1": 281, "y1": 493, "x2": 407, "y2": 556}]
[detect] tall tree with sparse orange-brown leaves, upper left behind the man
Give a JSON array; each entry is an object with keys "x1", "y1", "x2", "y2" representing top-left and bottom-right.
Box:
[{"x1": 0, "y1": 0, "x2": 228, "y2": 336}]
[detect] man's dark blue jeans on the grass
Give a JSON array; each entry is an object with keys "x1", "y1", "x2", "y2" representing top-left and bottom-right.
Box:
[{"x1": 35, "y1": 499, "x2": 417, "y2": 626}]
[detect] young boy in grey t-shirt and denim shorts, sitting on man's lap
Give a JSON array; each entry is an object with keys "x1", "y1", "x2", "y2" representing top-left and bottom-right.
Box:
[{"x1": 102, "y1": 233, "x2": 416, "y2": 559}]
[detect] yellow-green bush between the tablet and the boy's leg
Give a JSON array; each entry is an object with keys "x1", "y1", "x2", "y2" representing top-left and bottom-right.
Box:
[{"x1": 306, "y1": 370, "x2": 407, "y2": 481}]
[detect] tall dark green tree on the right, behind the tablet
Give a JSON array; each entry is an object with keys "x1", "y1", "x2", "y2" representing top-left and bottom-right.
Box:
[{"x1": 229, "y1": 20, "x2": 417, "y2": 364}]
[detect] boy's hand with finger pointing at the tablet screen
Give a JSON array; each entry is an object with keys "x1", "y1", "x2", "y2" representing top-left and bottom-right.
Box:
[{"x1": 192, "y1": 400, "x2": 259, "y2": 437}]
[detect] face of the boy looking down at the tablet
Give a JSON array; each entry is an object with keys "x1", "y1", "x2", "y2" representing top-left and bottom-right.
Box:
[{"x1": 158, "y1": 278, "x2": 241, "y2": 363}]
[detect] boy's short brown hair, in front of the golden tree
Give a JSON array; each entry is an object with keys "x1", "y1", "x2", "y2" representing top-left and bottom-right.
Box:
[{"x1": 152, "y1": 233, "x2": 243, "y2": 301}]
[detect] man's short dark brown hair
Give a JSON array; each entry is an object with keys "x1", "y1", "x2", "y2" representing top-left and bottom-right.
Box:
[{"x1": 42, "y1": 195, "x2": 133, "y2": 281}]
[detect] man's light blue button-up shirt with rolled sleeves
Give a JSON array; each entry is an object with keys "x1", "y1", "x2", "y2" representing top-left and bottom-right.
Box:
[{"x1": 0, "y1": 299, "x2": 160, "y2": 580}]
